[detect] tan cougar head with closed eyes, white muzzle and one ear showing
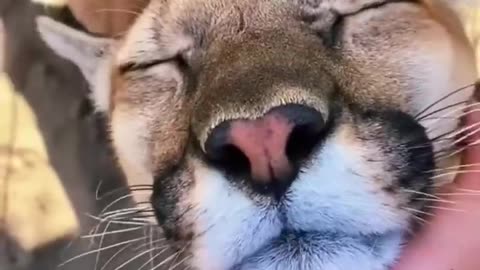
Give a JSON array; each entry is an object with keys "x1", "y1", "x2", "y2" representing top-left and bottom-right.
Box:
[{"x1": 39, "y1": 0, "x2": 476, "y2": 270}]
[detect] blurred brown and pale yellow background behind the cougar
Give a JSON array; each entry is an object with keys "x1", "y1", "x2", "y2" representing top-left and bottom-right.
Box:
[{"x1": 0, "y1": 0, "x2": 480, "y2": 270}]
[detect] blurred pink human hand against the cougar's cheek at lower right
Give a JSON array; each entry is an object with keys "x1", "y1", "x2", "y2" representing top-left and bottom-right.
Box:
[{"x1": 394, "y1": 91, "x2": 480, "y2": 270}]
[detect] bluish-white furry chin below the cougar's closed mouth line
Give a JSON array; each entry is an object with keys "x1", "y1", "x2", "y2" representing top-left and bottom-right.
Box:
[{"x1": 231, "y1": 230, "x2": 402, "y2": 270}]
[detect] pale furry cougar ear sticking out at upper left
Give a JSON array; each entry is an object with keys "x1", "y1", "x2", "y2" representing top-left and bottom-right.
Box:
[{"x1": 36, "y1": 16, "x2": 114, "y2": 111}]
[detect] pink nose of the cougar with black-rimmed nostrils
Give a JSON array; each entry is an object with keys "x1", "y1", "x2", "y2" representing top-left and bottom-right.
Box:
[{"x1": 205, "y1": 104, "x2": 325, "y2": 196}]
